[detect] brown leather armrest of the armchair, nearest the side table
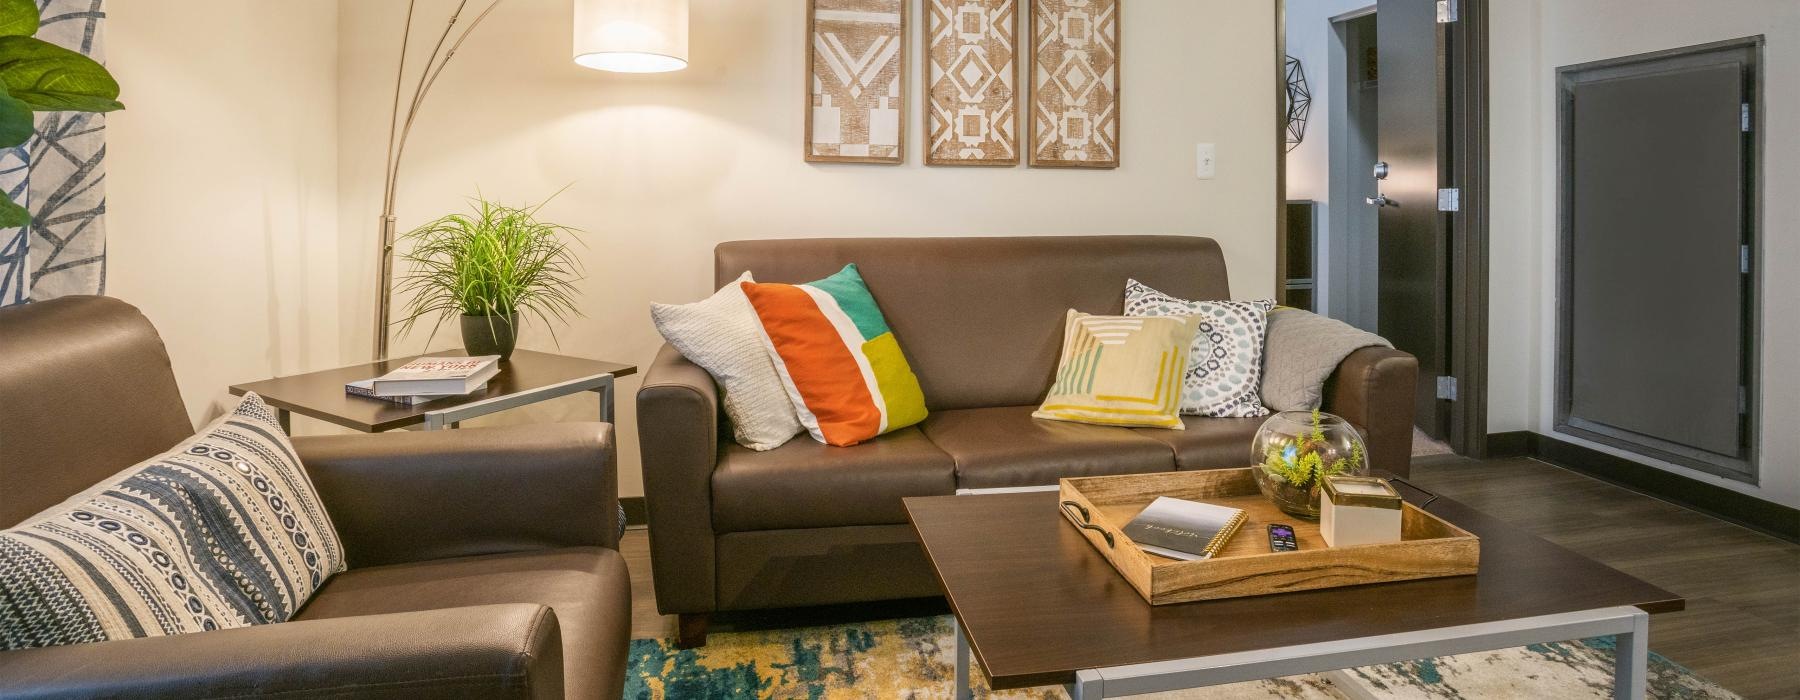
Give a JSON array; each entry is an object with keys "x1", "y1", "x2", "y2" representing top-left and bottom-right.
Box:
[{"x1": 293, "y1": 423, "x2": 619, "y2": 569}]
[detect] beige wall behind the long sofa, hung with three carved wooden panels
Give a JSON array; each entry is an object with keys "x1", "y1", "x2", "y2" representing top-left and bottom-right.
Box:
[{"x1": 337, "y1": 0, "x2": 1274, "y2": 495}]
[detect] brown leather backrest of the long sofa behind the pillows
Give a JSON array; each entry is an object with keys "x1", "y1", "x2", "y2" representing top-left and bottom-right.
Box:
[{"x1": 713, "y1": 236, "x2": 1229, "y2": 410}]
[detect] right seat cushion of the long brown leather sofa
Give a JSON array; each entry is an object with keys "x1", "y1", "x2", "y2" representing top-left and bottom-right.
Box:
[{"x1": 920, "y1": 407, "x2": 1173, "y2": 488}]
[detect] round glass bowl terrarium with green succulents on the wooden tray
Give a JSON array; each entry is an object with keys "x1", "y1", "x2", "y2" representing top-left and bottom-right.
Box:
[{"x1": 1251, "y1": 410, "x2": 1368, "y2": 520}]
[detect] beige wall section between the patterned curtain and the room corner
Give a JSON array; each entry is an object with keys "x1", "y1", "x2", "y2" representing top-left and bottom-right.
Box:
[{"x1": 106, "y1": 0, "x2": 342, "y2": 423}]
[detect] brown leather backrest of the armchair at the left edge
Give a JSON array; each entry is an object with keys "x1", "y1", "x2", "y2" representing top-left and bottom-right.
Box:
[{"x1": 0, "y1": 297, "x2": 192, "y2": 527}]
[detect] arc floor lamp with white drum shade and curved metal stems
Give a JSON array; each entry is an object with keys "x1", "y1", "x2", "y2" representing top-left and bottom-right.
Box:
[{"x1": 374, "y1": 0, "x2": 688, "y2": 360}]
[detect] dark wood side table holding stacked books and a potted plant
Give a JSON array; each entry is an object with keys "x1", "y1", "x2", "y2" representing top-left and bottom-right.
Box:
[{"x1": 230, "y1": 349, "x2": 637, "y2": 432}]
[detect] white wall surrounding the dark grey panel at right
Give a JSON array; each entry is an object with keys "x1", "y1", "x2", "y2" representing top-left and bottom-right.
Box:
[{"x1": 1489, "y1": 0, "x2": 1800, "y2": 506}]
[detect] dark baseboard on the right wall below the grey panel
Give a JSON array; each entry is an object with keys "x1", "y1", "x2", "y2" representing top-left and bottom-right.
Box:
[{"x1": 1487, "y1": 430, "x2": 1800, "y2": 543}]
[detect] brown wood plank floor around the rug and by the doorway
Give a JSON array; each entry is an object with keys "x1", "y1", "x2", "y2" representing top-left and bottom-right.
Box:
[{"x1": 619, "y1": 455, "x2": 1800, "y2": 698}]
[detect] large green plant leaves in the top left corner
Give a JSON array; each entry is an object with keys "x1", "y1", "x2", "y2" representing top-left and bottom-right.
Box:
[{"x1": 0, "y1": 0, "x2": 124, "y2": 229}]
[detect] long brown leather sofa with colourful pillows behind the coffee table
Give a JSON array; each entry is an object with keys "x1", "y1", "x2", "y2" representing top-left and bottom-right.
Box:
[{"x1": 637, "y1": 236, "x2": 1418, "y2": 644}]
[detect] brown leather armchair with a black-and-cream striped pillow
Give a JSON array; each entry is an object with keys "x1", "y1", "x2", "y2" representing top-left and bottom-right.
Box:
[{"x1": 0, "y1": 297, "x2": 632, "y2": 698}]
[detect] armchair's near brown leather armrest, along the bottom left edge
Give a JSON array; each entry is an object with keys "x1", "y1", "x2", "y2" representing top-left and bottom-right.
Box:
[{"x1": 0, "y1": 603, "x2": 563, "y2": 698}]
